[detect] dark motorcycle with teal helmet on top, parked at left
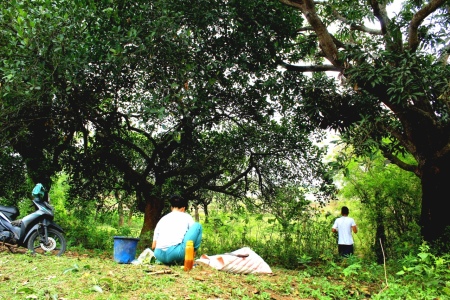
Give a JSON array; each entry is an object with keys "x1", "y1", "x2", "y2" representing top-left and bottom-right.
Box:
[{"x1": 0, "y1": 183, "x2": 67, "y2": 256}]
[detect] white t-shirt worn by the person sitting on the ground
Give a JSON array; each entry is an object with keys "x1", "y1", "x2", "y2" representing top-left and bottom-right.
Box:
[{"x1": 153, "y1": 211, "x2": 194, "y2": 250}]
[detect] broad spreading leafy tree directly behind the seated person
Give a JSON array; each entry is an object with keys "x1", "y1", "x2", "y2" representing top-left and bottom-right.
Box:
[{"x1": 0, "y1": 0, "x2": 328, "y2": 240}]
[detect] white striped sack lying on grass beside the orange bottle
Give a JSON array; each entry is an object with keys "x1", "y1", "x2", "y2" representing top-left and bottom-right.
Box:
[{"x1": 195, "y1": 247, "x2": 272, "y2": 274}]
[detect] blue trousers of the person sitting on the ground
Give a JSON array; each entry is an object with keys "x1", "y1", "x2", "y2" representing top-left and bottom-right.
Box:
[{"x1": 154, "y1": 222, "x2": 203, "y2": 265}]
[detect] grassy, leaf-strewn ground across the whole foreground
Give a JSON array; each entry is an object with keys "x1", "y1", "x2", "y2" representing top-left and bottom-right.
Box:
[{"x1": 0, "y1": 245, "x2": 450, "y2": 300}]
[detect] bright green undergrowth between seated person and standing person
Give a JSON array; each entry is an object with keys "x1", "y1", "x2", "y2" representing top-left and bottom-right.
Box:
[{"x1": 200, "y1": 207, "x2": 336, "y2": 268}]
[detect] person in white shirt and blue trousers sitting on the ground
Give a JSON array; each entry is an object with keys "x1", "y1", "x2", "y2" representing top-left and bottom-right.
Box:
[{"x1": 152, "y1": 195, "x2": 203, "y2": 265}]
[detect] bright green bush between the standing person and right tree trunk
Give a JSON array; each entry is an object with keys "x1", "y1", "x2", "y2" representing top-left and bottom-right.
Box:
[{"x1": 339, "y1": 151, "x2": 421, "y2": 262}]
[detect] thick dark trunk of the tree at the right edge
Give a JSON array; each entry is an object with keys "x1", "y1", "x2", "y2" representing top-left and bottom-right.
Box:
[{"x1": 420, "y1": 155, "x2": 450, "y2": 243}]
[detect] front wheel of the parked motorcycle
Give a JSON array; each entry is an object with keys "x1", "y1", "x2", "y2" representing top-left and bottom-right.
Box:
[{"x1": 27, "y1": 228, "x2": 66, "y2": 256}]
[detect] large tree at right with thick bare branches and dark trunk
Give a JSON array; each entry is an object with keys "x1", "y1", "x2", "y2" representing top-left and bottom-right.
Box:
[{"x1": 280, "y1": 0, "x2": 450, "y2": 241}]
